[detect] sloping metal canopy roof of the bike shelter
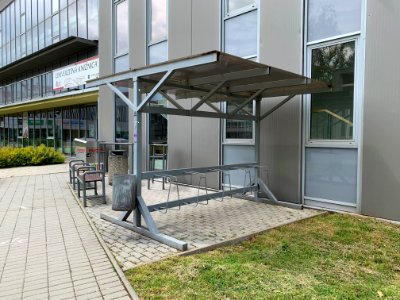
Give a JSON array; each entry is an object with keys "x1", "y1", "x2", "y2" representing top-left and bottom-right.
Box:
[{"x1": 87, "y1": 51, "x2": 330, "y2": 118}]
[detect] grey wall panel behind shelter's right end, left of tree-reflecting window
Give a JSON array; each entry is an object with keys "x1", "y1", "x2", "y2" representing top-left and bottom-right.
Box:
[{"x1": 259, "y1": 0, "x2": 303, "y2": 203}]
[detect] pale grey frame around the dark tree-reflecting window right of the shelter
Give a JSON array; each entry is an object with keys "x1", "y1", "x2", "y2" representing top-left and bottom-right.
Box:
[{"x1": 304, "y1": 34, "x2": 363, "y2": 148}]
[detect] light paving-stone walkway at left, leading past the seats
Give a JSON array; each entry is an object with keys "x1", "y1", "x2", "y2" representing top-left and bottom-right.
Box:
[{"x1": 0, "y1": 172, "x2": 131, "y2": 300}]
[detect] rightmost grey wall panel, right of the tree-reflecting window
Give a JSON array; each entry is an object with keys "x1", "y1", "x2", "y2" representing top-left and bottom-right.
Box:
[{"x1": 361, "y1": 0, "x2": 400, "y2": 221}]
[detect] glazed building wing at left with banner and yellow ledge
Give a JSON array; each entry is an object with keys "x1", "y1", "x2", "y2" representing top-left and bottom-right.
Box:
[{"x1": 0, "y1": 0, "x2": 99, "y2": 155}]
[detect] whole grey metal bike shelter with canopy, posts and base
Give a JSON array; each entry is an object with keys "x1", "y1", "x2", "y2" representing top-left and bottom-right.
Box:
[{"x1": 87, "y1": 51, "x2": 330, "y2": 251}]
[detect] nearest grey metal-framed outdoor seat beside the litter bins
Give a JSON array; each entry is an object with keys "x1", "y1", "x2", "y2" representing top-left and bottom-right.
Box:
[{"x1": 76, "y1": 166, "x2": 107, "y2": 207}]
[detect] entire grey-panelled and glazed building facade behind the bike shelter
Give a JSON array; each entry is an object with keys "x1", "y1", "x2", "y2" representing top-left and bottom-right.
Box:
[{"x1": 0, "y1": 0, "x2": 400, "y2": 220}]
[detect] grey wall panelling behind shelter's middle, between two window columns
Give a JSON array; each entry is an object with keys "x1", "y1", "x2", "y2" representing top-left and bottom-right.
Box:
[{"x1": 168, "y1": 0, "x2": 220, "y2": 187}]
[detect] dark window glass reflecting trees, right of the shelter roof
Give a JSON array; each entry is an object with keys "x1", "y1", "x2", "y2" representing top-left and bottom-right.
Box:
[{"x1": 310, "y1": 42, "x2": 355, "y2": 140}]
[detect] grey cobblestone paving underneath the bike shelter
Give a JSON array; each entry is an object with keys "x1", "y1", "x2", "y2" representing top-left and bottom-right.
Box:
[{"x1": 80, "y1": 176, "x2": 320, "y2": 270}]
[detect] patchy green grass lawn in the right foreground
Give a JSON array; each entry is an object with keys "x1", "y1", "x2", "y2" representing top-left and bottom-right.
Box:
[{"x1": 126, "y1": 214, "x2": 400, "y2": 299}]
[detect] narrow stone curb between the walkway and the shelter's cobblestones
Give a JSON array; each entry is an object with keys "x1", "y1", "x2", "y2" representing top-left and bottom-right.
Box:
[{"x1": 66, "y1": 182, "x2": 140, "y2": 300}]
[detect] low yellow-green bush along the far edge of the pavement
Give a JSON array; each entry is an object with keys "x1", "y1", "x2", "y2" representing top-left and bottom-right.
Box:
[{"x1": 0, "y1": 145, "x2": 65, "y2": 168}]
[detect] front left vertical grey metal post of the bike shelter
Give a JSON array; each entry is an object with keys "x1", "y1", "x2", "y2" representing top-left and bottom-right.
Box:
[{"x1": 133, "y1": 78, "x2": 142, "y2": 227}]
